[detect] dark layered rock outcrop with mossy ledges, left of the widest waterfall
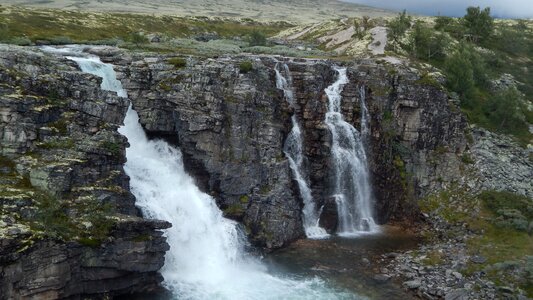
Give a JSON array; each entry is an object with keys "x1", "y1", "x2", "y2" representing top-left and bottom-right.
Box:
[{"x1": 0, "y1": 45, "x2": 170, "y2": 299}]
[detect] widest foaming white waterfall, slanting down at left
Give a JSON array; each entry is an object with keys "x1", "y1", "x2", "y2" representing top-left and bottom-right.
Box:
[{"x1": 55, "y1": 49, "x2": 363, "y2": 300}]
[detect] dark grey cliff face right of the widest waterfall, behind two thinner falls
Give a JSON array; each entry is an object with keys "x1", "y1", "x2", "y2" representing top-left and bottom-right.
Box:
[{"x1": 113, "y1": 55, "x2": 466, "y2": 248}]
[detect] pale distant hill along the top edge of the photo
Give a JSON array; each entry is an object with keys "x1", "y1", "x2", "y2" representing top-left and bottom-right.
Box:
[{"x1": 2, "y1": 0, "x2": 393, "y2": 23}]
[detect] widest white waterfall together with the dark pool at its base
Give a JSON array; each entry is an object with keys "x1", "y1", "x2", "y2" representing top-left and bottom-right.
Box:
[{"x1": 41, "y1": 48, "x2": 417, "y2": 300}]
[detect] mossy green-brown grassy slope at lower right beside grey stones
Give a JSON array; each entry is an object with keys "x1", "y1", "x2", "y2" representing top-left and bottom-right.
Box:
[{"x1": 420, "y1": 186, "x2": 533, "y2": 297}]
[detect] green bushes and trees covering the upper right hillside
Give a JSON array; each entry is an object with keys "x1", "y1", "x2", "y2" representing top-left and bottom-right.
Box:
[{"x1": 389, "y1": 7, "x2": 533, "y2": 145}]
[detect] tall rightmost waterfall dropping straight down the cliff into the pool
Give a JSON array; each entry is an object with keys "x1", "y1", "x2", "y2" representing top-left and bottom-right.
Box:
[{"x1": 325, "y1": 68, "x2": 378, "y2": 236}]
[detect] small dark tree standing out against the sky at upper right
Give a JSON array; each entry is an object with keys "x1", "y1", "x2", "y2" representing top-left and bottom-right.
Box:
[{"x1": 463, "y1": 6, "x2": 494, "y2": 43}]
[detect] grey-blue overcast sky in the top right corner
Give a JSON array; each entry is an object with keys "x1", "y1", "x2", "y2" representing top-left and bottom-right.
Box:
[{"x1": 343, "y1": 0, "x2": 533, "y2": 18}]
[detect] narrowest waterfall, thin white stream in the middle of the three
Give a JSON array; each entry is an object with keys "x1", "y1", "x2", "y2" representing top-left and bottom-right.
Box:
[{"x1": 274, "y1": 63, "x2": 329, "y2": 239}]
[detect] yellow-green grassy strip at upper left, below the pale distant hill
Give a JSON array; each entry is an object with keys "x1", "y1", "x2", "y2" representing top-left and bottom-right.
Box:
[{"x1": 0, "y1": 7, "x2": 292, "y2": 44}]
